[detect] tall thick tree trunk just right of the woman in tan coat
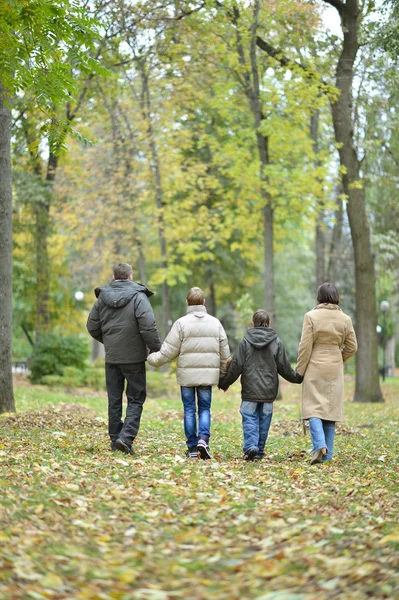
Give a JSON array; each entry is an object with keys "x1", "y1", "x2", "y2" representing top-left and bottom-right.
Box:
[{"x1": 328, "y1": 0, "x2": 383, "y2": 402}]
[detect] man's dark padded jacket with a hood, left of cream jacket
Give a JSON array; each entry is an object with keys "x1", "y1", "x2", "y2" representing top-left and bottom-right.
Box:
[{"x1": 87, "y1": 279, "x2": 161, "y2": 364}]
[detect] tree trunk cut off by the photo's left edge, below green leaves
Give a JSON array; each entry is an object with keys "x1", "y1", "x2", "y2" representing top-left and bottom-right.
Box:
[{"x1": 0, "y1": 83, "x2": 15, "y2": 413}]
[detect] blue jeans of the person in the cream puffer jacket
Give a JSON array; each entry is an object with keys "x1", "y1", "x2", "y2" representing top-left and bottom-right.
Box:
[{"x1": 180, "y1": 385, "x2": 212, "y2": 448}]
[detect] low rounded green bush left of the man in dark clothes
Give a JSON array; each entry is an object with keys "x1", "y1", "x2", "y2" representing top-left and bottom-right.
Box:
[{"x1": 29, "y1": 333, "x2": 88, "y2": 383}]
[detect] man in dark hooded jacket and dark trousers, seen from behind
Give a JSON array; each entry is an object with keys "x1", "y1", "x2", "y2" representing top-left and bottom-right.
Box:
[{"x1": 87, "y1": 263, "x2": 161, "y2": 454}]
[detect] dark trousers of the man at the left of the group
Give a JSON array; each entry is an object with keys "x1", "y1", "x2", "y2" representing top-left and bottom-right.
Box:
[{"x1": 105, "y1": 362, "x2": 146, "y2": 446}]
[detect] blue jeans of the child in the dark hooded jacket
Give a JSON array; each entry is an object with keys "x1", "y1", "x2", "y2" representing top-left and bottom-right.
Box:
[{"x1": 240, "y1": 401, "x2": 273, "y2": 456}]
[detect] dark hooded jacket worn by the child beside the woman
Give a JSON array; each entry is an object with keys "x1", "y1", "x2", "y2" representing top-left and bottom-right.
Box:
[{"x1": 219, "y1": 327, "x2": 303, "y2": 402}]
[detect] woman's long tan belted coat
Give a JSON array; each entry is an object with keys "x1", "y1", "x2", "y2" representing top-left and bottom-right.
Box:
[{"x1": 296, "y1": 304, "x2": 357, "y2": 421}]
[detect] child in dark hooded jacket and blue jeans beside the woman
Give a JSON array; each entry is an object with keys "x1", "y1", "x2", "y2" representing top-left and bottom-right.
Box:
[{"x1": 219, "y1": 310, "x2": 303, "y2": 460}]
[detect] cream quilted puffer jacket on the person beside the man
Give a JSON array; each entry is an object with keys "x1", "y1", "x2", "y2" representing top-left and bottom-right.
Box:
[{"x1": 147, "y1": 305, "x2": 230, "y2": 387}]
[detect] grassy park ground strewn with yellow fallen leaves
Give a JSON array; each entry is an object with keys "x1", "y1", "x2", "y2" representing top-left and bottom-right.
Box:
[{"x1": 0, "y1": 379, "x2": 399, "y2": 600}]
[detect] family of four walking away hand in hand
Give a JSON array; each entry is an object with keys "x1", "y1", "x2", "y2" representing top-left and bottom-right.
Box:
[{"x1": 87, "y1": 263, "x2": 357, "y2": 464}]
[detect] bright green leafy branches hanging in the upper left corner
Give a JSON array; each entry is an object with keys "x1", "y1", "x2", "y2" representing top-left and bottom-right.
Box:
[{"x1": 0, "y1": 0, "x2": 105, "y2": 152}]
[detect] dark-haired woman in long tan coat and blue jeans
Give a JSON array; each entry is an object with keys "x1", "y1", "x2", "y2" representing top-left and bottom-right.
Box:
[{"x1": 296, "y1": 283, "x2": 357, "y2": 465}]
